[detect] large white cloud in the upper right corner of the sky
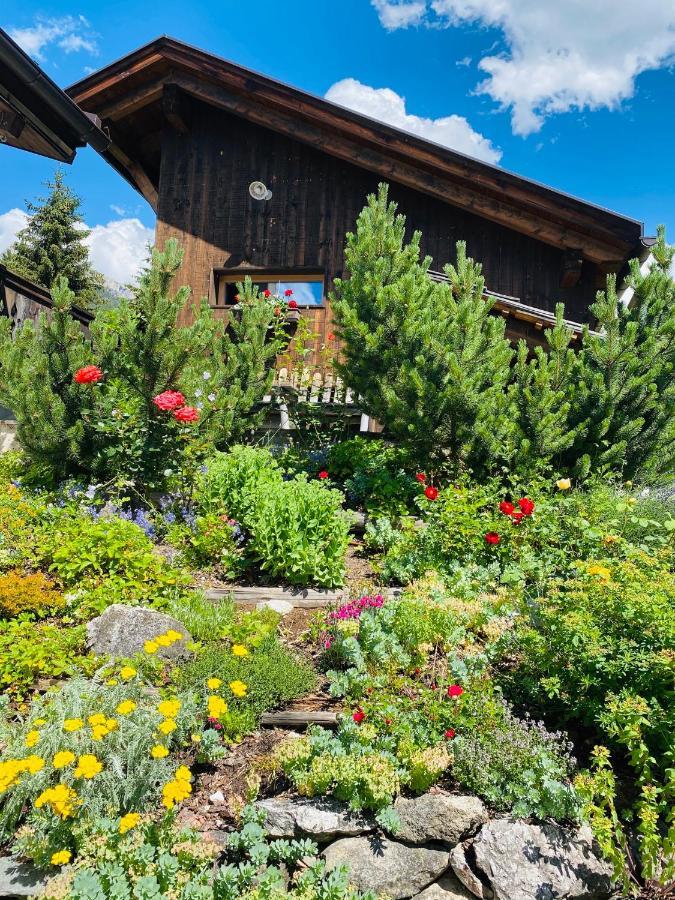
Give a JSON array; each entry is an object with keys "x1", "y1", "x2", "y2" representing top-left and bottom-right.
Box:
[{"x1": 372, "y1": 0, "x2": 675, "y2": 135}]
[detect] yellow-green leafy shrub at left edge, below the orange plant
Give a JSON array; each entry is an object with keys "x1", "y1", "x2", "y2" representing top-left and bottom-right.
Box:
[{"x1": 0, "y1": 619, "x2": 94, "y2": 697}]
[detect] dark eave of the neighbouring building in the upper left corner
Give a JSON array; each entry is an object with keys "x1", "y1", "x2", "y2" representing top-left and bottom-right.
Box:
[{"x1": 0, "y1": 28, "x2": 109, "y2": 163}]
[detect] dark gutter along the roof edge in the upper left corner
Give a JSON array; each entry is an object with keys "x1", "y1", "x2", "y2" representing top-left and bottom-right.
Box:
[{"x1": 0, "y1": 28, "x2": 111, "y2": 153}]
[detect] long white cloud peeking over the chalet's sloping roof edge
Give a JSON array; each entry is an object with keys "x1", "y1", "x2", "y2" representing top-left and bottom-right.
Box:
[{"x1": 326, "y1": 78, "x2": 502, "y2": 163}]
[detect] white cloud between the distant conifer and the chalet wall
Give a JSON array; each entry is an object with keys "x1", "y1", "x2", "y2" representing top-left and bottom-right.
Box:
[{"x1": 85, "y1": 219, "x2": 155, "y2": 284}]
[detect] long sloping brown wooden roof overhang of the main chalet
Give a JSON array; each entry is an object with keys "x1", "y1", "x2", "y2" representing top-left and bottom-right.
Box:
[{"x1": 67, "y1": 37, "x2": 642, "y2": 270}]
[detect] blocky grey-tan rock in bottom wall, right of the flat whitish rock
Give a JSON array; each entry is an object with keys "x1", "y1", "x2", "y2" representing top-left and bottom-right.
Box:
[{"x1": 394, "y1": 793, "x2": 488, "y2": 846}]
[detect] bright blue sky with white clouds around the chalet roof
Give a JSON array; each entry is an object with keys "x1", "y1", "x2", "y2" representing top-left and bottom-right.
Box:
[{"x1": 0, "y1": 0, "x2": 675, "y2": 280}]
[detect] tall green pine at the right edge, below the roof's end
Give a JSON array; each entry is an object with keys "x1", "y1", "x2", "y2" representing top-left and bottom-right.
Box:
[{"x1": 565, "y1": 227, "x2": 675, "y2": 478}]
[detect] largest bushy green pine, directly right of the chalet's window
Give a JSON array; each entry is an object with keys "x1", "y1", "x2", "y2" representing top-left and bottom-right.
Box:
[{"x1": 332, "y1": 185, "x2": 512, "y2": 472}]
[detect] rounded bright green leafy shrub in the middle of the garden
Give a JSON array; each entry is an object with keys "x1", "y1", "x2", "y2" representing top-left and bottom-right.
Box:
[{"x1": 247, "y1": 476, "x2": 349, "y2": 587}]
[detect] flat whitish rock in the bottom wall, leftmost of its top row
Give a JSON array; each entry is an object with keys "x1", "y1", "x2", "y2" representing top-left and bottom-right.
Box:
[{"x1": 257, "y1": 797, "x2": 375, "y2": 844}]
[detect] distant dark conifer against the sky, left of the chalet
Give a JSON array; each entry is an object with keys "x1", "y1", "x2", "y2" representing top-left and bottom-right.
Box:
[{"x1": 0, "y1": 169, "x2": 103, "y2": 309}]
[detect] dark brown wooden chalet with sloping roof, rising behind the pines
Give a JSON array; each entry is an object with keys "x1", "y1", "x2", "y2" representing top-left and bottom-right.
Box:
[{"x1": 67, "y1": 37, "x2": 644, "y2": 364}]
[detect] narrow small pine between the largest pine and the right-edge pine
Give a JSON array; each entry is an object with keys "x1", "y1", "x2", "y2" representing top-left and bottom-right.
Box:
[{"x1": 509, "y1": 303, "x2": 577, "y2": 473}]
